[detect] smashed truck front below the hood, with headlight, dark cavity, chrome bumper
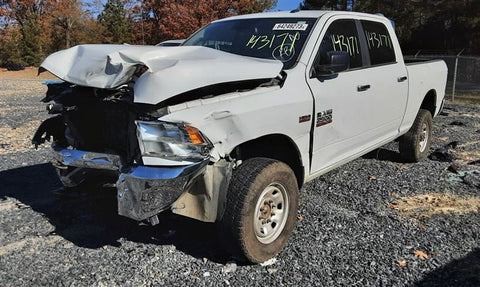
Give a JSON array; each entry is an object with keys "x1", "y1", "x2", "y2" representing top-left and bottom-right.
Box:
[{"x1": 32, "y1": 82, "x2": 212, "y2": 223}]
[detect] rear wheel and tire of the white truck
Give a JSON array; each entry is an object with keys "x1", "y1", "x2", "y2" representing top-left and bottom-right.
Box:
[{"x1": 399, "y1": 109, "x2": 433, "y2": 162}]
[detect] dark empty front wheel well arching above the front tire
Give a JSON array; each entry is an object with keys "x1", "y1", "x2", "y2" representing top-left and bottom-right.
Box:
[{"x1": 230, "y1": 134, "x2": 305, "y2": 188}]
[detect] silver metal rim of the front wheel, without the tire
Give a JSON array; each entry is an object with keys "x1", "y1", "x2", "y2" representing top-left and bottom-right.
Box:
[{"x1": 253, "y1": 183, "x2": 289, "y2": 244}]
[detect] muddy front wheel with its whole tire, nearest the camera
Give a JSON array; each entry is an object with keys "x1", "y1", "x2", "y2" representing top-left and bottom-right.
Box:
[{"x1": 219, "y1": 158, "x2": 298, "y2": 263}]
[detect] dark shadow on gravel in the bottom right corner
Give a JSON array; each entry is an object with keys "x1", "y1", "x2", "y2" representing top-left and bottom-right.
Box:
[{"x1": 414, "y1": 248, "x2": 480, "y2": 287}]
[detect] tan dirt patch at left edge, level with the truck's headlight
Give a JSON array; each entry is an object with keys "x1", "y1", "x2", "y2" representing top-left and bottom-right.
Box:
[{"x1": 0, "y1": 121, "x2": 41, "y2": 154}]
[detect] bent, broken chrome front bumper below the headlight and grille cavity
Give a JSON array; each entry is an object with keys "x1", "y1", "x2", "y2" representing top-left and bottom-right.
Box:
[{"x1": 55, "y1": 149, "x2": 208, "y2": 221}]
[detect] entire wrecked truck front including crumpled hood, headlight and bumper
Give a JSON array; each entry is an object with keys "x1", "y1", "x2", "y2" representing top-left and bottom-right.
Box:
[{"x1": 32, "y1": 45, "x2": 284, "y2": 223}]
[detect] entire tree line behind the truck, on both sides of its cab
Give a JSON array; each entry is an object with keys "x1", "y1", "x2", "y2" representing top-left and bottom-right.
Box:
[{"x1": 0, "y1": 0, "x2": 480, "y2": 65}]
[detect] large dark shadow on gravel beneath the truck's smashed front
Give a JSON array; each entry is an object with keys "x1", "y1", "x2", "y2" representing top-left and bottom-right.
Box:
[{"x1": 0, "y1": 164, "x2": 229, "y2": 263}]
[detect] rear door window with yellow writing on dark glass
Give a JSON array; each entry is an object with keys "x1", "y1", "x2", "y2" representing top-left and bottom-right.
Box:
[{"x1": 360, "y1": 20, "x2": 395, "y2": 65}]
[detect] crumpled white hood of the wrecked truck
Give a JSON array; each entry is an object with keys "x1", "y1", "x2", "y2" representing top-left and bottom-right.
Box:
[{"x1": 39, "y1": 45, "x2": 283, "y2": 104}]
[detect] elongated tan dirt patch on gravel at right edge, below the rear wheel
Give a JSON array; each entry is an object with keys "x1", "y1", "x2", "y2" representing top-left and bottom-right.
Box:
[{"x1": 389, "y1": 193, "x2": 480, "y2": 218}]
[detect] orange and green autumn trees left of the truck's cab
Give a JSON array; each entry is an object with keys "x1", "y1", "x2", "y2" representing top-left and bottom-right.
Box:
[{"x1": 0, "y1": 0, "x2": 277, "y2": 65}]
